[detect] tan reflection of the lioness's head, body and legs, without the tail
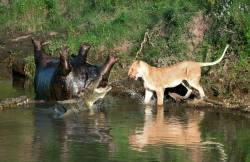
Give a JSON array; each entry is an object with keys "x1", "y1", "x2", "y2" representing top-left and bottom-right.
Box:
[{"x1": 130, "y1": 107, "x2": 204, "y2": 148}]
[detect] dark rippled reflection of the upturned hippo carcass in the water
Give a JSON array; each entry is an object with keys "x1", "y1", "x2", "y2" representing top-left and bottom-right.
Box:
[{"x1": 33, "y1": 104, "x2": 115, "y2": 161}]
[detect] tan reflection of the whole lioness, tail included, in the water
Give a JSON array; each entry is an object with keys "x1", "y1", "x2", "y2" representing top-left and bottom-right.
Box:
[{"x1": 129, "y1": 106, "x2": 227, "y2": 162}]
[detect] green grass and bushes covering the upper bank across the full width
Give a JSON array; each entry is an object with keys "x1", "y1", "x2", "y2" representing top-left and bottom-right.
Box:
[{"x1": 0, "y1": 0, "x2": 250, "y2": 100}]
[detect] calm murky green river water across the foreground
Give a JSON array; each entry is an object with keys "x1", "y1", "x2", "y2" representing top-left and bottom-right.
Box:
[{"x1": 0, "y1": 76, "x2": 250, "y2": 162}]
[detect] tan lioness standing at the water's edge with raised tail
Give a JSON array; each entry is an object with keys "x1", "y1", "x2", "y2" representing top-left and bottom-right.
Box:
[{"x1": 128, "y1": 45, "x2": 229, "y2": 106}]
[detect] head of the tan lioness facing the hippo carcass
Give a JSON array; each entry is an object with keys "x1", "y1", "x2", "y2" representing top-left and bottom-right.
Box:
[{"x1": 128, "y1": 60, "x2": 146, "y2": 80}]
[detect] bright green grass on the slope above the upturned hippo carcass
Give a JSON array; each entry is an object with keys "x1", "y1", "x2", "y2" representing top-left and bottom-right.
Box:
[{"x1": 0, "y1": 0, "x2": 197, "y2": 57}]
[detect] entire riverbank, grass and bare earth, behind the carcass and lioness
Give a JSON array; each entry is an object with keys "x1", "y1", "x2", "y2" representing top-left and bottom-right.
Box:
[{"x1": 0, "y1": 0, "x2": 250, "y2": 109}]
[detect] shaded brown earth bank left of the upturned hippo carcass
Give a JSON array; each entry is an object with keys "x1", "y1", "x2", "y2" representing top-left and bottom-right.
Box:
[{"x1": 0, "y1": 32, "x2": 61, "y2": 78}]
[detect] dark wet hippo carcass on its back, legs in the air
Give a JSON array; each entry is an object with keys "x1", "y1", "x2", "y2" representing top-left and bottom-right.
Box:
[{"x1": 32, "y1": 39, "x2": 118, "y2": 101}]
